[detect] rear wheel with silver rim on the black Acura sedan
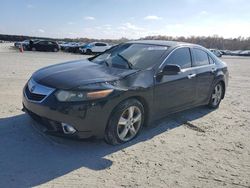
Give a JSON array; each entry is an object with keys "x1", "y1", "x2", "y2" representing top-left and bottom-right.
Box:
[{"x1": 208, "y1": 82, "x2": 225, "y2": 109}]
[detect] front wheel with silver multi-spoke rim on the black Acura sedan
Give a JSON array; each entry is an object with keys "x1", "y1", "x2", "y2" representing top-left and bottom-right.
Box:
[{"x1": 105, "y1": 99, "x2": 144, "y2": 145}]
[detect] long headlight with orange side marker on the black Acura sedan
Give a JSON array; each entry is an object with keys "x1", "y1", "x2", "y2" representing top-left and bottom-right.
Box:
[{"x1": 55, "y1": 89, "x2": 113, "y2": 102}]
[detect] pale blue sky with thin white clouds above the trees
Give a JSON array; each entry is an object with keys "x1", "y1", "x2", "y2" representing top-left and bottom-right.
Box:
[{"x1": 0, "y1": 0, "x2": 250, "y2": 39}]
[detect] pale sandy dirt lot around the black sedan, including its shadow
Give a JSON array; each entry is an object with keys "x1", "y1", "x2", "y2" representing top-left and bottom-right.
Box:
[{"x1": 0, "y1": 44, "x2": 250, "y2": 188}]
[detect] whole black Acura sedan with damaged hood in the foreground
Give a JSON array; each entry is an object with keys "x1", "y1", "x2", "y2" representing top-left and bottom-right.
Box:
[{"x1": 23, "y1": 41, "x2": 228, "y2": 144}]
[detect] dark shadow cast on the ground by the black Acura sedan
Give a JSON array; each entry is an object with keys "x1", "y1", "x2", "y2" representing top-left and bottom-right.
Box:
[{"x1": 0, "y1": 107, "x2": 211, "y2": 187}]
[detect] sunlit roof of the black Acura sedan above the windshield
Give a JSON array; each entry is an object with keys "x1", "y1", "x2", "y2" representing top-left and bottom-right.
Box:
[{"x1": 127, "y1": 40, "x2": 200, "y2": 47}]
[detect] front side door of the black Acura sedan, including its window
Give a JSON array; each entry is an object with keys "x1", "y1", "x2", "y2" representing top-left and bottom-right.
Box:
[{"x1": 154, "y1": 47, "x2": 196, "y2": 117}]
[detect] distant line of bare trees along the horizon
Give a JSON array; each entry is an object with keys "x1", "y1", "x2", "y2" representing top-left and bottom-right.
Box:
[{"x1": 0, "y1": 34, "x2": 250, "y2": 50}]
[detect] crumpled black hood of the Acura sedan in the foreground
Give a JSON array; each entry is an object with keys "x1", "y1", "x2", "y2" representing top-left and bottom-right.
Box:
[{"x1": 32, "y1": 60, "x2": 138, "y2": 89}]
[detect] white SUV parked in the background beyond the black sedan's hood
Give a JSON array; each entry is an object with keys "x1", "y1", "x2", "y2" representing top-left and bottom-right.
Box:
[{"x1": 79, "y1": 42, "x2": 111, "y2": 55}]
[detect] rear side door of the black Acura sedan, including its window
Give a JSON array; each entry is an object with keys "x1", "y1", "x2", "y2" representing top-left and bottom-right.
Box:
[{"x1": 191, "y1": 48, "x2": 216, "y2": 104}]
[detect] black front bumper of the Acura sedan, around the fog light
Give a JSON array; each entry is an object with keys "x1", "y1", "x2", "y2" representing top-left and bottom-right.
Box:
[{"x1": 23, "y1": 85, "x2": 115, "y2": 138}]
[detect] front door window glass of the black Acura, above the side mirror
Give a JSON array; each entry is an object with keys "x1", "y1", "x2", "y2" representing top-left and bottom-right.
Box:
[{"x1": 166, "y1": 48, "x2": 191, "y2": 69}]
